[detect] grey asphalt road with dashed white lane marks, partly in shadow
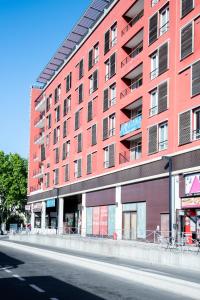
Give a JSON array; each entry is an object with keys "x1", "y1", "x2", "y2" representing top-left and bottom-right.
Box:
[{"x1": 0, "y1": 241, "x2": 200, "y2": 300}]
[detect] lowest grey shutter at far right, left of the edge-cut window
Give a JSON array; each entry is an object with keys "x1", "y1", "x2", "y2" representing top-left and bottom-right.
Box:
[{"x1": 179, "y1": 110, "x2": 191, "y2": 145}]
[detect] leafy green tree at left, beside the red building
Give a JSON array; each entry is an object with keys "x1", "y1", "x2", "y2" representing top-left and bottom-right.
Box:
[{"x1": 0, "y1": 151, "x2": 28, "y2": 223}]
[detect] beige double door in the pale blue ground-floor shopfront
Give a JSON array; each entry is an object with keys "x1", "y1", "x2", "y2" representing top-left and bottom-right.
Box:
[{"x1": 123, "y1": 211, "x2": 137, "y2": 240}]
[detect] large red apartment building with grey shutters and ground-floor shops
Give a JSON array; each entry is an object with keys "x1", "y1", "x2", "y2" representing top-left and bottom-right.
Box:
[{"x1": 27, "y1": 0, "x2": 200, "y2": 239}]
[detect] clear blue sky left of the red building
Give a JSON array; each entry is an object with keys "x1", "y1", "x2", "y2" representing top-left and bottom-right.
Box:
[{"x1": 0, "y1": 0, "x2": 91, "y2": 157}]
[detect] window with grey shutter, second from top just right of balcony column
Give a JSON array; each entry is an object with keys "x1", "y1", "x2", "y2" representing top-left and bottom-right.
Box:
[{"x1": 150, "y1": 43, "x2": 168, "y2": 80}]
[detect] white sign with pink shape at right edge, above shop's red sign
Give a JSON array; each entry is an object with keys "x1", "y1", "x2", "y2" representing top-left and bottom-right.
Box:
[{"x1": 185, "y1": 173, "x2": 200, "y2": 196}]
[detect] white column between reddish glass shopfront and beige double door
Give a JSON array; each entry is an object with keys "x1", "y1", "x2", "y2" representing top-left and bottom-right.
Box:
[{"x1": 115, "y1": 186, "x2": 122, "y2": 240}]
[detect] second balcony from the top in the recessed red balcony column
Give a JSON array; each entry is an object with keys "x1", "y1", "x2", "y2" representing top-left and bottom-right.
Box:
[{"x1": 121, "y1": 29, "x2": 143, "y2": 68}]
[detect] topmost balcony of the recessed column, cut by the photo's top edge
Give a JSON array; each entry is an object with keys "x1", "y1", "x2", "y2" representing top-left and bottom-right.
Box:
[{"x1": 121, "y1": 0, "x2": 144, "y2": 37}]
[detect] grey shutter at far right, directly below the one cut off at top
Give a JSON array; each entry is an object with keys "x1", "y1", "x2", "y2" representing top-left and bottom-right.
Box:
[{"x1": 181, "y1": 23, "x2": 193, "y2": 59}]
